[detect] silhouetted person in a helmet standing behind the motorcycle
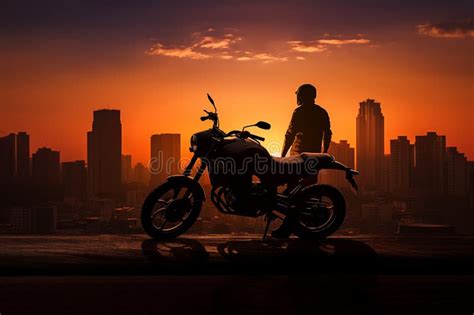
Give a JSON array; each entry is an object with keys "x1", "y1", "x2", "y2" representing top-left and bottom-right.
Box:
[{"x1": 272, "y1": 84, "x2": 332, "y2": 238}]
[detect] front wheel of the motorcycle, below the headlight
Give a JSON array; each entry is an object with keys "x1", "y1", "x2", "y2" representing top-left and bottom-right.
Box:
[{"x1": 141, "y1": 182, "x2": 202, "y2": 240}]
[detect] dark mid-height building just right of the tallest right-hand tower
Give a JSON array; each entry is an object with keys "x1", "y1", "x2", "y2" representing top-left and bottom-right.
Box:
[{"x1": 390, "y1": 136, "x2": 415, "y2": 195}]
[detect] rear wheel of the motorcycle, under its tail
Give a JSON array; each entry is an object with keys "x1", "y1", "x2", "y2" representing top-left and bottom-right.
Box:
[{"x1": 294, "y1": 185, "x2": 346, "y2": 239}]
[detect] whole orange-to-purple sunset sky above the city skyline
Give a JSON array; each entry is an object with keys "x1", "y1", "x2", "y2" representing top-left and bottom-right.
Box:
[{"x1": 0, "y1": 0, "x2": 474, "y2": 163}]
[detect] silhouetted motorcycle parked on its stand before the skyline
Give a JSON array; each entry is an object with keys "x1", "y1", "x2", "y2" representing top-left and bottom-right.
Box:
[{"x1": 141, "y1": 94, "x2": 359, "y2": 239}]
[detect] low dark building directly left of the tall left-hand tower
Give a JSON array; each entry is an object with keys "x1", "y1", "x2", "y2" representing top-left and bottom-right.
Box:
[{"x1": 62, "y1": 161, "x2": 87, "y2": 206}]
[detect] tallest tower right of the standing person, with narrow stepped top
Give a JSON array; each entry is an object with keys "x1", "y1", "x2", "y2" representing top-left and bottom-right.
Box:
[{"x1": 356, "y1": 99, "x2": 384, "y2": 190}]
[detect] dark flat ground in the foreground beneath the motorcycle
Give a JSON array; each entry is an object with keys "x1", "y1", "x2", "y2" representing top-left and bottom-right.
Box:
[{"x1": 0, "y1": 235, "x2": 474, "y2": 315}]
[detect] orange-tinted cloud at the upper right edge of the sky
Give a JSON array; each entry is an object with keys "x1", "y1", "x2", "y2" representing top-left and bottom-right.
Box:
[{"x1": 416, "y1": 18, "x2": 474, "y2": 38}]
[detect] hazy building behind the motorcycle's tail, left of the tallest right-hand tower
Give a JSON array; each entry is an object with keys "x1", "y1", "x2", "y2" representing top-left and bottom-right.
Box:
[{"x1": 320, "y1": 140, "x2": 355, "y2": 188}]
